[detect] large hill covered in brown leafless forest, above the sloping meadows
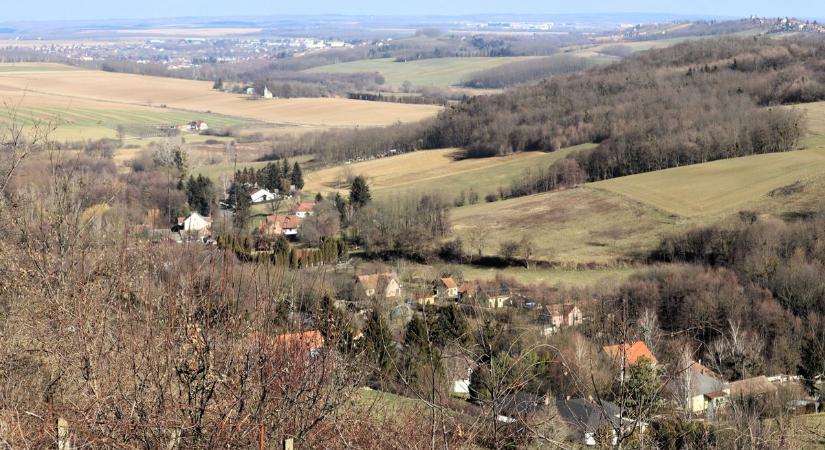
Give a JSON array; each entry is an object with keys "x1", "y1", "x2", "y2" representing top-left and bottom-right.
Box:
[{"x1": 428, "y1": 38, "x2": 825, "y2": 180}]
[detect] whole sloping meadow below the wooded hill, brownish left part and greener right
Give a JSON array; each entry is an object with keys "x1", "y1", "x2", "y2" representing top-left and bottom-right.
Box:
[{"x1": 452, "y1": 150, "x2": 825, "y2": 264}]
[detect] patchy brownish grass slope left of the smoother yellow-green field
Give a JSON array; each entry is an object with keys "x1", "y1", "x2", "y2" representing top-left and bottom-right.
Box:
[{"x1": 451, "y1": 187, "x2": 679, "y2": 266}]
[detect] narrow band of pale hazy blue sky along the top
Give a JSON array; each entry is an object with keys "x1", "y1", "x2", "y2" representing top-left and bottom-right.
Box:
[{"x1": 6, "y1": 0, "x2": 825, "y2": 23}]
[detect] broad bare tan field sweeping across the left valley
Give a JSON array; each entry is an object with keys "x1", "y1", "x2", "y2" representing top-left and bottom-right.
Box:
[{"x1": 0, "y1": 62, "x2": 440, "y2": 127}]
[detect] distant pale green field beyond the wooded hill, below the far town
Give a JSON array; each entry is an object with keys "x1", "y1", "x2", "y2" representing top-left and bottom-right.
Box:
[{"x1": 307, "y1": 56, "x2": 531, "y2": 88}]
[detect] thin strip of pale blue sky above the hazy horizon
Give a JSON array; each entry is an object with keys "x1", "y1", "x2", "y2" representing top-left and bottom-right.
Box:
[{"x1": 6, "y1": 0, "x2": 825, "y2": 21}]
